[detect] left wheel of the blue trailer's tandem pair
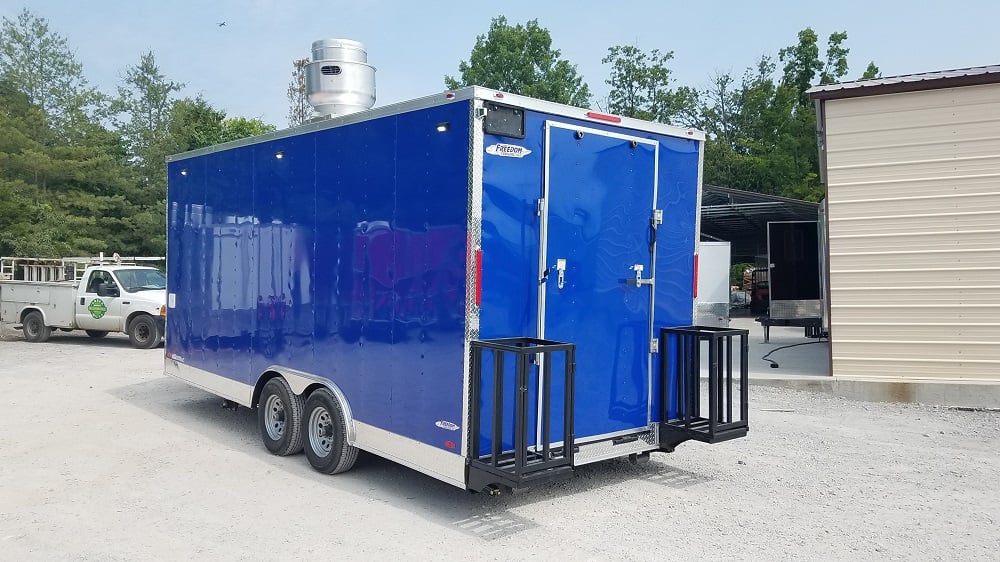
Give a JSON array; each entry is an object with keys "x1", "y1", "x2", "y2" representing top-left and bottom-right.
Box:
[{"x1": 257, "y1": 377, "x2": 302, "y2": 457}]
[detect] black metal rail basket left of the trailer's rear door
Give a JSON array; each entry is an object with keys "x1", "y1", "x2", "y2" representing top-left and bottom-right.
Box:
[{"x1": 466, "y1": 337, "x2": 576, "y2": 491}]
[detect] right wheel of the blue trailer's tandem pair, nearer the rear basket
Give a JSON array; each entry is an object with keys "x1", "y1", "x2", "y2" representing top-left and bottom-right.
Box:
[{"x1": 302, "y1": 388, "x2": 358, "y2": 474}]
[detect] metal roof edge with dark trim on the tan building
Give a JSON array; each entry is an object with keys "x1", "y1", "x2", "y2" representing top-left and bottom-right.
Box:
[{"x1": 808, "y1": 64, "x2": 1000, "y2": 99}]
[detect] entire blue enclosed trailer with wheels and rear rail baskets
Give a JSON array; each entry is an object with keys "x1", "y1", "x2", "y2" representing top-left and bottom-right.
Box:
[{"x1": 165, "y1": 87, "x2": 746, "y2": 490}]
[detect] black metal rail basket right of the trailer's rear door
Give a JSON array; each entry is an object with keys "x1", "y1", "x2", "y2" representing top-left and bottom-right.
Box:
[{"x1": 660, "y1": 326, "x2": 749, "y2": 451}]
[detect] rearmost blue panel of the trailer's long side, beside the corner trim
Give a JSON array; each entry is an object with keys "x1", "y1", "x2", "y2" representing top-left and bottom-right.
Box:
[{"x1": 387, "y1": 103, "x2": 469, "y2": 446}]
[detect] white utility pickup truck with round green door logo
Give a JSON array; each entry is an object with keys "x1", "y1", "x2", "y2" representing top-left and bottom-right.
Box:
[{"x1": 0, "y1": 258, "x2": 167, "y2": 349}]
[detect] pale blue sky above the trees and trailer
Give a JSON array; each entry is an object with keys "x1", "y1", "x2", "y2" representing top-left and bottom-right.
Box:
[{"x1": 0, "y1": 0, "x2": 1000, "y2": 128}]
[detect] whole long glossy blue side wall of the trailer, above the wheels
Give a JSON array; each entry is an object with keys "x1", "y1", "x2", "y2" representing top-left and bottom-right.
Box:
[{"x1": 168, "y1": 99, "x2": 470, "y2": 453}]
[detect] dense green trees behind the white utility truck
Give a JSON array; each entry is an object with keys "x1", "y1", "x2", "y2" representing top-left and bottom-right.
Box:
[{"x1": 0, "y1": 11, "x2": 274, "y2": 257}]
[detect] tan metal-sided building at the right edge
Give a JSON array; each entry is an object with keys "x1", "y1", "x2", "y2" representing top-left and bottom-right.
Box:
[{"x1": 810, "y1": 65, "x2": 1000, "y2": 382}]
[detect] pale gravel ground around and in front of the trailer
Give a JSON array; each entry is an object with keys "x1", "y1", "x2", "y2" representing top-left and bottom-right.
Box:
[{"x1": 0, "y1": 328, "x2": 1000, "y2": 560}]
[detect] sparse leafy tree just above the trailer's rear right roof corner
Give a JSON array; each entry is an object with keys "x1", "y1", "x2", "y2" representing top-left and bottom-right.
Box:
[{"x1": 601, "y1": 45, "x2": 698, "y2": 125}]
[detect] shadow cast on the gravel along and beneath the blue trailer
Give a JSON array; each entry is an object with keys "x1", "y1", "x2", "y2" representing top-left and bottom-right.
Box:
[{"x1": 110, "y1": 377, "x2": 710, "y2": 541}]
